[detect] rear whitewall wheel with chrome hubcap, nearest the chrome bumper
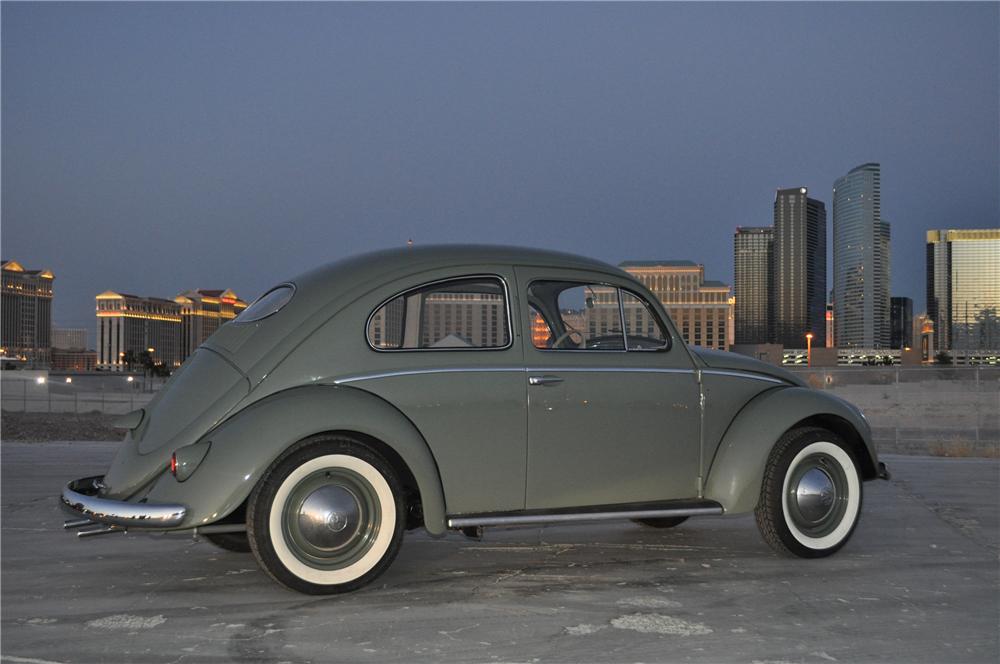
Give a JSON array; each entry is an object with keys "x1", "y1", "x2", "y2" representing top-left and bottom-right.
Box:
[{"x1": 247, "y1": 436, "x2": 406, "y2": 595}]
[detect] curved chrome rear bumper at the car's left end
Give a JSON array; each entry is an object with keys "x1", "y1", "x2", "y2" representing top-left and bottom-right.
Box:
[{"x1": 62, "y1": 475, "x2": 187, "y2": 529}]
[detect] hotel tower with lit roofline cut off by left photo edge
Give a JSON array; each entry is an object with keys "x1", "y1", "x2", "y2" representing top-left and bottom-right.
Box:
[{"x1": 0, "y1": 260, "x2": 55, "y2": 367}]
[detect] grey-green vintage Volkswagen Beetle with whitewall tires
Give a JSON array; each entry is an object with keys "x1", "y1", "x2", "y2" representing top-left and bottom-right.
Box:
[{"x1": 62, "y1": 246, "x2": 887, "y2": 594}]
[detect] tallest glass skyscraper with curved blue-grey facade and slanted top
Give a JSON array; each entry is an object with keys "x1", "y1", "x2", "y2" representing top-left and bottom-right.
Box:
[{"x1": 833, "y1": 163, "x2": 891, "y2": 348}]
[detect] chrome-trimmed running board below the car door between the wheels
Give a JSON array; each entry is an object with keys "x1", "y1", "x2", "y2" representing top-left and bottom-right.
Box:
[{"x1": 448, "y1": 500, "x2": 724, "y2": 528}]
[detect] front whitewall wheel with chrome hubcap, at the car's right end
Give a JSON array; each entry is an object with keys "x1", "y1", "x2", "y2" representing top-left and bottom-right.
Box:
[{"x1": 754, "y1": 428, "x2": 862, "y2": 558}]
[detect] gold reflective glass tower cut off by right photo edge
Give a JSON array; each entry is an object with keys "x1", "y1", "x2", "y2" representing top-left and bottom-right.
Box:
[{"x1": 927, "y1": 228, "x2": 1000, "y2": 351}]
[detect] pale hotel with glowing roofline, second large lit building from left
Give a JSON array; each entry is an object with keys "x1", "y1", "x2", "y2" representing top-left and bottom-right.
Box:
[{"x1": 96, "y1": 291, "x2": 183, "y2": 371}]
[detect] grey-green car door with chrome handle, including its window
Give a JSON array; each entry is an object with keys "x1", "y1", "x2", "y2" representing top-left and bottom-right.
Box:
[{"x1": 516, "y1": 267, "x2": 700, "y2": 509}]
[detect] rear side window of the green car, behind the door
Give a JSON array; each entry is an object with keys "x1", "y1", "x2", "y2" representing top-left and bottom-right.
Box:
[{"x1": 367, "y1": 277, "x2": 511, "y2": 350}]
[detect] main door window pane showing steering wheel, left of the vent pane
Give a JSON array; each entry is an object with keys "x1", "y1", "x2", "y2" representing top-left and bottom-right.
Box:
[{"x1": 528, "y1": 281, "x2": 625, "y2": 350}]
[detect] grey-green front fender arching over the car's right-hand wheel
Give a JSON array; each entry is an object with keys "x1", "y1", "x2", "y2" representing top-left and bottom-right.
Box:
[{"x1": 705, "y1": 387, "x2": 878, "y2": 513}]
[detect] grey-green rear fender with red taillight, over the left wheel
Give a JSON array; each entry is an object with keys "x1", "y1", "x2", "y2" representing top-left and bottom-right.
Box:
[{"x1": 147, "y1": 385, "x2": 446, "y2": 535}]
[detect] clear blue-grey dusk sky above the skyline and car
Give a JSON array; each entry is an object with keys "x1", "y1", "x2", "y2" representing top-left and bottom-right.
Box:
[{"x1": 0, "y1": 2, "x2": 1000, "y2": 334}]
